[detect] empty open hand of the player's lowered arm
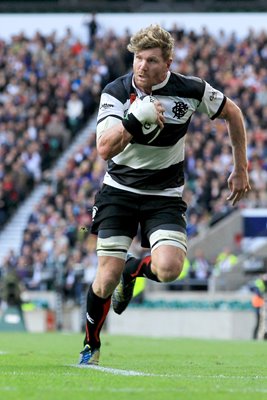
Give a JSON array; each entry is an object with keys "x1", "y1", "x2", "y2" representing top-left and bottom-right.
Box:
[{"x1": 226, "y1": 170, "x2": 251, "y2": 206}]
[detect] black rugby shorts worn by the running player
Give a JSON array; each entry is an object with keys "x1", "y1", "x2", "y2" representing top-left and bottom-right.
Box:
[{"x1": 91, "y1": 185, "x2": 187, "y2": 248}]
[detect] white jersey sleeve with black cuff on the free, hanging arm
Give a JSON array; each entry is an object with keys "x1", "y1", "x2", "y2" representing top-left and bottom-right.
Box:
[{"x1": 197, "y1": 82, "x2": 226, "y2": 119}]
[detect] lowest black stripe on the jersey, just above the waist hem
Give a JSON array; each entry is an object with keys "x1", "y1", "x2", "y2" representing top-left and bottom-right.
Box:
[{"x1": 108, "y1": 160, "x2": 184, "y2": 190}]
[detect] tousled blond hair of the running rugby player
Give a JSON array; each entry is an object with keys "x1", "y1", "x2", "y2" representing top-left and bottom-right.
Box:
[{"x1": 127, "y1": 24, "x2": 174, "y2": 60}]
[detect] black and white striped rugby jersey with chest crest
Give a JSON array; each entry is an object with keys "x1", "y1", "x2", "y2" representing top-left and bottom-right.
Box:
[{"x1": 97, "y1": 72, "x2": 226, "y2": 196}]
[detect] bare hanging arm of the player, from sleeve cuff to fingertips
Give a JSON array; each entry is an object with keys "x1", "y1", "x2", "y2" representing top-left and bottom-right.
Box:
[{"x1": 219, "y1": 98, "x2": 251, "y2": 205}]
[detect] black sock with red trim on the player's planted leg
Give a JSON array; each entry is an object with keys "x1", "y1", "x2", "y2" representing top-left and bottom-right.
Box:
[{"x1": 84, "y1": 285, "x2": 111, "y2": 349}]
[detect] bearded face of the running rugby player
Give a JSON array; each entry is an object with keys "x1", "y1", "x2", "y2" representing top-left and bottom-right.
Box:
[{"x1": 133, "y1": 47, "x2": 171, "y2": 94}]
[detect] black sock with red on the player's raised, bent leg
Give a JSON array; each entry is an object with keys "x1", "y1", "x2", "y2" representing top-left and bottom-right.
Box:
[{"x1": 123, "y1": 256, "x2": 159, "y2": 283}]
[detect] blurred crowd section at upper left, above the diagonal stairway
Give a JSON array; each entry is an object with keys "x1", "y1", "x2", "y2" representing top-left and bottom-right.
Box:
[{"x1": 0, "y1": 24, "x2": 132, "y2": 226}]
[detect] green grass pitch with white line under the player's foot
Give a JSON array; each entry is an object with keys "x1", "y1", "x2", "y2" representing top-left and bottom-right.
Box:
[{"x1": 0, "y1": 333, "x2": 267, "y2": 400}]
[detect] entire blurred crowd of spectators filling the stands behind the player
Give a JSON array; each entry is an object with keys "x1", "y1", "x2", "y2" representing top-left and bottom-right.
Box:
[{"x1": 0, "y1": 21, "x2": 267, "y2": 302}]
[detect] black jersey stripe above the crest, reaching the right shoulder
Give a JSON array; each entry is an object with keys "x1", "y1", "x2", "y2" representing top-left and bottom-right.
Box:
[{"x1": 152, "y1": 72, "x2": 206, "y2": 102}]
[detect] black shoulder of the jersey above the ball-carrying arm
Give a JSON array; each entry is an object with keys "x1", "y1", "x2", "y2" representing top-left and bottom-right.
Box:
[{"x1": 102, "y1": 73, "x2": 133, "y2": 103}]
